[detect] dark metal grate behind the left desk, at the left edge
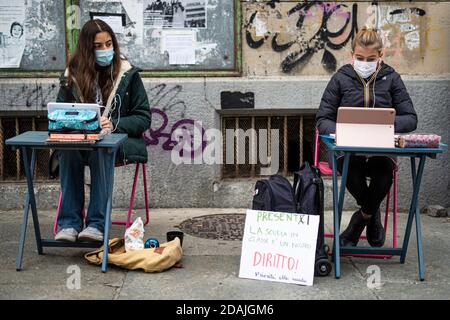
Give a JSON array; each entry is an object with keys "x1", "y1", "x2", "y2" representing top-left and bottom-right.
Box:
[{"x1": 0, "y1": 115, "x2": 51, "y2": 181}]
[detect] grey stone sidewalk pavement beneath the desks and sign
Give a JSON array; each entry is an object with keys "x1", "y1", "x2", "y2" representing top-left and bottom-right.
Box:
[{"x1": 0, "y1": 209, "x2": 450, "y2": 300}]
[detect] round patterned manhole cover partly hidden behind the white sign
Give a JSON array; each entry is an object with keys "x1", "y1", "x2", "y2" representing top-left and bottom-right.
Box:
[{"x1": 179, "y1": 214, "x2": 245, "y2": 240}]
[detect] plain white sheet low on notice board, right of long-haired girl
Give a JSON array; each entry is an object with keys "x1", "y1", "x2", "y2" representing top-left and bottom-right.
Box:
[{"x1": 161, "y1": 30, "x2": 196, "y2": 65}]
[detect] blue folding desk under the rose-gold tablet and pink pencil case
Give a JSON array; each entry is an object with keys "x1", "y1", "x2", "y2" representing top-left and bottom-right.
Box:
[{"x1": 321, "y1": 136, "x2": 443, "y2": 281}]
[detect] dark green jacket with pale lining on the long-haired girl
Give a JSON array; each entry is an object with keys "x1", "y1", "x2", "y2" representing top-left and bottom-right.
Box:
[{"x1": 56, "y1": 60, "x2": 151, "y2": 164}]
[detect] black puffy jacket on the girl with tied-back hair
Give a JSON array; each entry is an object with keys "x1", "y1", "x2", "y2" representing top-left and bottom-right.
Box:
[{"x1": 316, "y1": 63, "x2": 417, "y2": 134}]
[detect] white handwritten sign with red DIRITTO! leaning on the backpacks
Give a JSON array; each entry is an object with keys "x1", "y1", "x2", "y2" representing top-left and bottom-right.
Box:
[{"x1": 239, "y1": 210, "x2": 319, "y2": 286}]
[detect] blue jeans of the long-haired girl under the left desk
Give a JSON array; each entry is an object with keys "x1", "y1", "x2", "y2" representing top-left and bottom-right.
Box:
[{"x1": 58, "y1": 150, "x2": 113, "y2": 232}]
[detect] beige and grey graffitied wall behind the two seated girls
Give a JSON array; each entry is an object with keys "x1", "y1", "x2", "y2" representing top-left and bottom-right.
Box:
[{"x1": 0, "y1": 1, "x2": 450, "y2": 209}]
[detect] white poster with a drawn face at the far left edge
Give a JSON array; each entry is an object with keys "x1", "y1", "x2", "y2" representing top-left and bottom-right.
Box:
[{"x1": 0, "y1": 0, "x2": 25, "y2": 68}]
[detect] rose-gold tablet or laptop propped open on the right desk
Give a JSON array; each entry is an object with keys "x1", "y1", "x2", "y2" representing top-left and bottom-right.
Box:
[{"x1": 336, "y1": 107, "x2": 395, "y2": 148}]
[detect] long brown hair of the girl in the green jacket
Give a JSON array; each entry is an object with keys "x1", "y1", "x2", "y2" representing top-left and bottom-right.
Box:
[{"x1": 68, "y1": 19, "x2": 121, "y2": 103}]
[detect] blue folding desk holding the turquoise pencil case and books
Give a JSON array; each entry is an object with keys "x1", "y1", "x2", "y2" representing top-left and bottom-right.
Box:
[{"x1": 5, "y1": 131, "x2": 127, "y2": 272}]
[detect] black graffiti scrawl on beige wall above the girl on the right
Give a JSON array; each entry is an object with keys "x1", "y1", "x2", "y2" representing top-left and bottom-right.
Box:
[{"x1": 244, "y1": 1, "x2": 426, "y2": 73}]
